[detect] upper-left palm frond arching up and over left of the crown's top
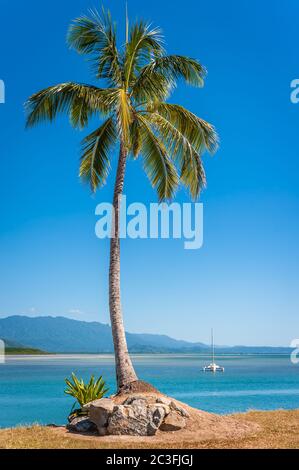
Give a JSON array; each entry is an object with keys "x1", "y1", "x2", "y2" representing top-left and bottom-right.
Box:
[{"x1": 67, "y1": 9, "x2": 123, "y2": 86}]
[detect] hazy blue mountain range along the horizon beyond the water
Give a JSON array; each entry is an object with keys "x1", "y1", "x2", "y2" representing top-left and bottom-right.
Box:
[{"x1": 0, "y1": 315, "x2": 290, "y2": 354}]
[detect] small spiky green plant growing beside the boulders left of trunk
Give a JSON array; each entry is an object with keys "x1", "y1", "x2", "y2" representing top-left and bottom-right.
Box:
[{"x1": 64, "y1": 372, "x2": 109, "y2": 419}]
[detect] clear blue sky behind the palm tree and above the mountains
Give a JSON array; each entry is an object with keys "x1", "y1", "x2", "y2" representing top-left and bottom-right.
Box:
[{"x1": 0, "y1": 0, "x2": 299, "y2": 345}]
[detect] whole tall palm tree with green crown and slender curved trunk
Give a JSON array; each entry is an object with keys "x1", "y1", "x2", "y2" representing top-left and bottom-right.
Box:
[{"x1": 26, "y1": 10, "x2": 217, "y2": 391}]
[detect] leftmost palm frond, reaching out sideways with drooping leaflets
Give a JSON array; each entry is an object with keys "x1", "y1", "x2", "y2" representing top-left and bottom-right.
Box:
[{"x1": 25, "y1": 82, "x2": 117, "y2": 127}]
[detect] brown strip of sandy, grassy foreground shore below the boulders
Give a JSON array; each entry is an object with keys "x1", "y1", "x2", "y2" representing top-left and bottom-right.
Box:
[{"x1": 0, "y1": 410, "x2": 299, "y2": 449}]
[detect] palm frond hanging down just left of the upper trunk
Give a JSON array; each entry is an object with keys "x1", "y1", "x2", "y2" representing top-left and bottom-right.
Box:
[{"x1": 79, "y1": 117, "x2": 117, "y2": 191}]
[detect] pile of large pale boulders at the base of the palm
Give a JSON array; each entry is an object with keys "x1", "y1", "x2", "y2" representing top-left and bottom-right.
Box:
[{"x1": 67, "y1": 394, "x2": 189, "y2": 436}]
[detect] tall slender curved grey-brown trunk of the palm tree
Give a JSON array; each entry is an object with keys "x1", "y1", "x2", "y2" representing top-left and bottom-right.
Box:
[{"x1": 109, "y1": 143, "x2": 137, "y2": 391}]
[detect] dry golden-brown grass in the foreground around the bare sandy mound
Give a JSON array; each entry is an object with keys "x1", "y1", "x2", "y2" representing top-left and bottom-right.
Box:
[{"x1": 0, "y1": 410, "x2": 299, "y2": 449}]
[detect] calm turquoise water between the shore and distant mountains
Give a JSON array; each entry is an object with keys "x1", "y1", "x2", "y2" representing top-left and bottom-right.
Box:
[{"x1": 0, "y1": 355, "x2": 299, "y2": 427}]
